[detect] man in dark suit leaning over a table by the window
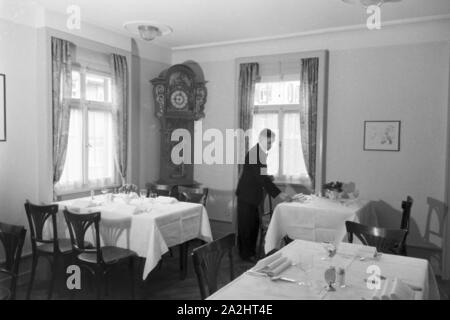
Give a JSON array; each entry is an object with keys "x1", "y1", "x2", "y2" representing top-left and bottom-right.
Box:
[{"x1": 236, "y1": 129, "x2": 288, "y2": 262}]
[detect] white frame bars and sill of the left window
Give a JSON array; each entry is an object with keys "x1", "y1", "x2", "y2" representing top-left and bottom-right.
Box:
[{"x1": 58, "y1": 63, "x2": 119, "y2": 195}]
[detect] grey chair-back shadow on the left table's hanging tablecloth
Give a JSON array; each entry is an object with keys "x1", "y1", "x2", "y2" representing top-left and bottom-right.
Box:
[{"x1": 100, "y1": 217, "x2": 131, "y2": 249}]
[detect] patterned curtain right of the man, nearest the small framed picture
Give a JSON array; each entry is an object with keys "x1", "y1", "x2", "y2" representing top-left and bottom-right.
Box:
[{"x1": 300, "y1": 58, "x2": 319, "y2": 190}]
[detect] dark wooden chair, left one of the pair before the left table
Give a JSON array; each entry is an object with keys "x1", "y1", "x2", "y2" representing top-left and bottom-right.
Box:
[{"x1": 25, "y1": 200, "x2": 88, "y2": 299}]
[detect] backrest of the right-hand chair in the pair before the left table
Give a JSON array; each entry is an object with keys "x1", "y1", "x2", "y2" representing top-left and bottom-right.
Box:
[{"x1": 64, "y1": 208, "x2": 104, "y2": 263}]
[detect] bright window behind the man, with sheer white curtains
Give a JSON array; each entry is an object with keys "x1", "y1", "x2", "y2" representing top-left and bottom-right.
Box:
[{"x1": 252, "y1": 80, "x2": 309, "y2": 184}]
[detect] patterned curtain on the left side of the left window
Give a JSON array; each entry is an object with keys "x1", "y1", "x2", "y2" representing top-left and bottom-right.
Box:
[{"x1": 52, "y1": 38, "x2": 75, "y2": 192}]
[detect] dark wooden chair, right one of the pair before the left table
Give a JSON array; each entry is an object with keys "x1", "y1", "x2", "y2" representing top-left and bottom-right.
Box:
[{"x1": 64, "y1": 209, "x2": 137, "y2": 299}]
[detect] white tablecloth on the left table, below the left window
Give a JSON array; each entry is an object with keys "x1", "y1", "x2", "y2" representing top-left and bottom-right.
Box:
[{"x1": 50, "y1": 196, "x2": 212, "y2": 279}]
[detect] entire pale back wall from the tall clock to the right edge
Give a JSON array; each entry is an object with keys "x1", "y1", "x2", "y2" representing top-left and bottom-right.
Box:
[{"x1": 173, "y1": 19, "x2": 450, "y2": 250}]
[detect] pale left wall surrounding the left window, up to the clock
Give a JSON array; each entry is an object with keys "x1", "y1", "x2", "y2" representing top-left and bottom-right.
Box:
[{"x1": 0, "y1": 16, "x2": 170, "y2": 260}]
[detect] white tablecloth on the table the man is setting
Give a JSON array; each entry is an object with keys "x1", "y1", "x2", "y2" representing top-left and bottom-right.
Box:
[{"x1": 264, "y1": 197, "x2": 378, "y2": 253}]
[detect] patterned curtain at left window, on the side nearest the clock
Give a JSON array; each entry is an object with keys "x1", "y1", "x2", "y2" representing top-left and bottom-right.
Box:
[{"x1": 111, "y1": 54, "x2": 128, "y2": 184}]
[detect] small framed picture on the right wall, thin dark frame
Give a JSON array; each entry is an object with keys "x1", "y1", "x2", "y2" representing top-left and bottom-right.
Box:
[{"x1": 364, "y1": 121, "x2": 401, "y2": 151}]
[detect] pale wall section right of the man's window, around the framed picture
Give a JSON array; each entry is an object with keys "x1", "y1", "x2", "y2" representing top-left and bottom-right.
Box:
[{"x1": 327, "y1": 43, "x2": 450, "y2": 248}]
